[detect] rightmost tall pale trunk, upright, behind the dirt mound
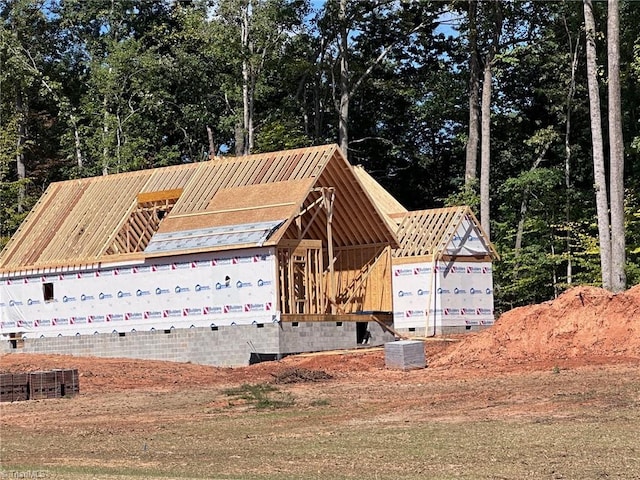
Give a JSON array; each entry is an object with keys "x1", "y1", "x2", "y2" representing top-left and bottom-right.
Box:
[{"x1": 607, "y1": 0, "x2": 627, "y2": 292}]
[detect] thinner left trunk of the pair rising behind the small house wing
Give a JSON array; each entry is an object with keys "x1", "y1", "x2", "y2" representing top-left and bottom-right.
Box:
[{"x1": 464, "y1": 1, "x2": 480, "y2": 187}]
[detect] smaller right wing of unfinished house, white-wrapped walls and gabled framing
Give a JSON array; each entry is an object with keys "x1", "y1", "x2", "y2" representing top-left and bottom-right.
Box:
[{"x1": 354, "y1": 167, "x2": 498, "y2": 336}]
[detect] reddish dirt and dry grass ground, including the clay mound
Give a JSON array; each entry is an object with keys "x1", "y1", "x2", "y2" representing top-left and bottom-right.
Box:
[{"x1": 0, "y1": 286, "x2": 640, "y2": 479}]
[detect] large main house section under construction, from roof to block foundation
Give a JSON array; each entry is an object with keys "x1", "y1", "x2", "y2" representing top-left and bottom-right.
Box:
[{"x1": 0, "y1": 145, "x2": 397, "y2": 365}]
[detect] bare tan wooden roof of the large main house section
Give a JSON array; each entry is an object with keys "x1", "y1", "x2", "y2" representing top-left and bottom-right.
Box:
[{"x1": 0, "y1": 145, "x2": 395, "y2": 272}]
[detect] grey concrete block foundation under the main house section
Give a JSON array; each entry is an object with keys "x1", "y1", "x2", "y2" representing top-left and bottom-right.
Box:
[{"x1": 0, "y1": 322, "x2": 394, "y2": 366}]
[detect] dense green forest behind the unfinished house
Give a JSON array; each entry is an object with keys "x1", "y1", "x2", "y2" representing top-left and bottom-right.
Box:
[{"x1": 0, "y1": 0, "x2": 640, "y2": 313}]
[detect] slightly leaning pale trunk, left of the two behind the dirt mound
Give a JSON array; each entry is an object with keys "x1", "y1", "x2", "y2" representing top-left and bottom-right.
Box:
[{"x1": 584, "y1": 0, "x2": 611, "y2": 290}]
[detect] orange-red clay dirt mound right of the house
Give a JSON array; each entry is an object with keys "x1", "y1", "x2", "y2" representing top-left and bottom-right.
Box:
[{"x1": 430, "y1": 285, "x2": 640, "y2": 366}]
